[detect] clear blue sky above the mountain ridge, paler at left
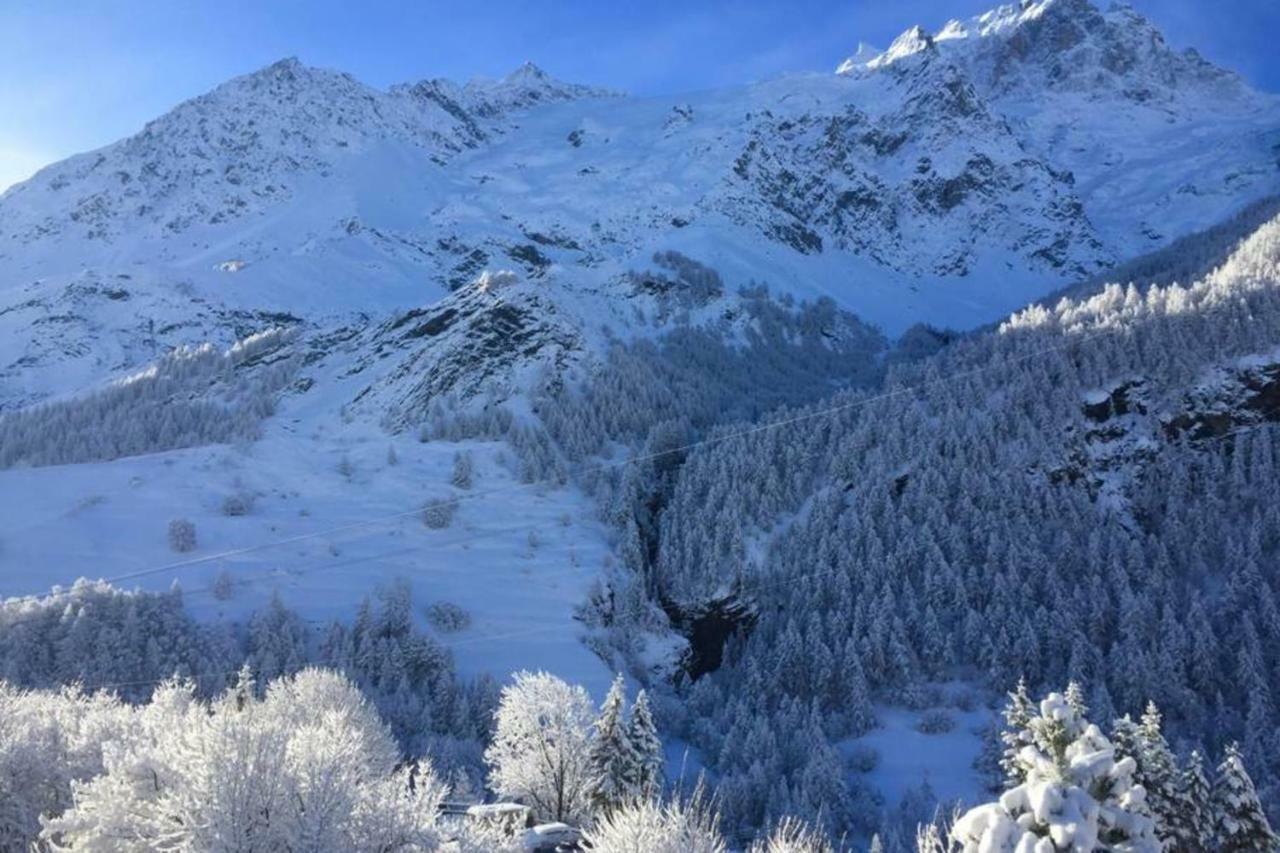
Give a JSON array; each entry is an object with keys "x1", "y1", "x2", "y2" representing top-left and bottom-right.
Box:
[{"x1": 0, "y1": 0, "x2": 1280, "y2": 190}]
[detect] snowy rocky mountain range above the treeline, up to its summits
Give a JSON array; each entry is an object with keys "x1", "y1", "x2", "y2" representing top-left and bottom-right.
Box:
[{"x1": 0, "y1": 0, "x2": 1280, "y2": 407}]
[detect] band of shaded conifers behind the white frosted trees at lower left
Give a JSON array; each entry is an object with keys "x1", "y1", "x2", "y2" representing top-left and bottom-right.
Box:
[{"x1": 0, "y1": 580, "x2": 498, "y2": 789}]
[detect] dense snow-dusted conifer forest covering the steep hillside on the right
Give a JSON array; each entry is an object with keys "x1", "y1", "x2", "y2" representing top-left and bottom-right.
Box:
[{"x1": 555, "y1": 204, "x2": 1280, "y2": 831}]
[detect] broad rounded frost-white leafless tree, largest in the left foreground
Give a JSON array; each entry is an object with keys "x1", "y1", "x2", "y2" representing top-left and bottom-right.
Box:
[{"x1": 42, "y1": 670, "x2": 447, "y2": 853}]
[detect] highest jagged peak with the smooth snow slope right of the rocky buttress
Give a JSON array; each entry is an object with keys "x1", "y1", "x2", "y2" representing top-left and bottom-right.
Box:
[{"x1": 840, "y1": 0, "x2": 1280, "y2": 256}]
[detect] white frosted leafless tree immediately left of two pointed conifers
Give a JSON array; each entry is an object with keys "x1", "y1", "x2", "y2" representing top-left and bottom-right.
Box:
[{"x1": 484, "y1": 672, "x2": 594, "y2": 822}]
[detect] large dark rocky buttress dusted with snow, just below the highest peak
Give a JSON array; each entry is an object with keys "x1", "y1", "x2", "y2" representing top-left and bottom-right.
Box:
[{"x1": 723, "y1": 54, "x2": 1112, "y2": 278}]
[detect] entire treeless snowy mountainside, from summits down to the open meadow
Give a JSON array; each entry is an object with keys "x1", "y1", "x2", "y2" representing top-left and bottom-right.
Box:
[{"x1": 0, "y1": 0, "x2": 1280, "y2": 701}]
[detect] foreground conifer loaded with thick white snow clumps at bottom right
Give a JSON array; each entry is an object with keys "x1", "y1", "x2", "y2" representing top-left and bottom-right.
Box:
[{"x1": 951, "y1": 693, "x2": 1162, "y2": 853}]
